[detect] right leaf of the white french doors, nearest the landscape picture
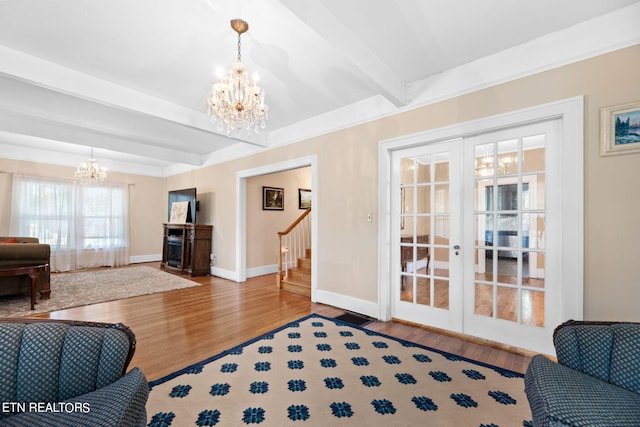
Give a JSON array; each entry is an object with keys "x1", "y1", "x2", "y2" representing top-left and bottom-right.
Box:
[{"x1": 463, "y1": 120, "x2": 562, "y2": 353}]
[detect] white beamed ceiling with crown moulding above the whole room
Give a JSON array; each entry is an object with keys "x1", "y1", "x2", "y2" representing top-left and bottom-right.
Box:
[{"x1": 0, "y1": 0, "x2": 640, "y2": 176}]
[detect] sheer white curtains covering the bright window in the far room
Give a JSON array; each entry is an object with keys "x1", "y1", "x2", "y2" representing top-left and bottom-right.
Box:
[{"x1": 10, "y1": 175, "x2": 129, "y2": 271}]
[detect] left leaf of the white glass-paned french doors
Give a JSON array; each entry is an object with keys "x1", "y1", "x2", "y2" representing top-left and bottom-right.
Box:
[{"x1": 391, "y1": 141, "x2": 462, "y2": 332}]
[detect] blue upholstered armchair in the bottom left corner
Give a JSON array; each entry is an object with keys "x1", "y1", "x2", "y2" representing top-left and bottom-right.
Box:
[{"x1": 0, "y1": 319, "x2": 149, "y2": 427}]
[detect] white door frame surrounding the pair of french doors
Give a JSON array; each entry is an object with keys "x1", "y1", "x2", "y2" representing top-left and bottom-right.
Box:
[{"x1": 378, "y1": 96, "x2": 584, "y2": 352}]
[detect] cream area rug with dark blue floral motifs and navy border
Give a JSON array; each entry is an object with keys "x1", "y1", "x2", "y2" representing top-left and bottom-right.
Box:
[{"x1": 147, "y1": 314, "x2": 532, "y2": 427}]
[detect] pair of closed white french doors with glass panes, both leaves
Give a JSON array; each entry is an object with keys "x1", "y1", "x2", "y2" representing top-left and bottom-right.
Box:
[{"x1": 390, "y1": 120, "x2": 562, "y2": 353}]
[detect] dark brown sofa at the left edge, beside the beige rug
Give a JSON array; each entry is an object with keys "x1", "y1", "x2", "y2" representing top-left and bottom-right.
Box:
[{"x1": 0, "y1": 236, "x2": 51, "y2": 298}]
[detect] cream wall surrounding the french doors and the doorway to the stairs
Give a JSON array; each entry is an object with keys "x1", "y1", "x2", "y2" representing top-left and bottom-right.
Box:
[{"x1": 168, "y1": 45, "x2": 640, "y2": 320}]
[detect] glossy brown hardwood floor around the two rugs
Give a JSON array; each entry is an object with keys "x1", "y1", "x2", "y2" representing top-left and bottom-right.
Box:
[{"x1": 34, "y1": 263, "x2": 530, "y2": 380}]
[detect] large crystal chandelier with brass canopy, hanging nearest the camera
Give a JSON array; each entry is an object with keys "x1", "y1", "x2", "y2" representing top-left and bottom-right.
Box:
[{"x1": 208, "y1": 19, "x2": 267, "y2": 135}]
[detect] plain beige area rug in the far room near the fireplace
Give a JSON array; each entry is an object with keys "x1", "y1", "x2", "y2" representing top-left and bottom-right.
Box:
[{"x1": 0, "y1": 266, "x2": 200, "y2": 317}]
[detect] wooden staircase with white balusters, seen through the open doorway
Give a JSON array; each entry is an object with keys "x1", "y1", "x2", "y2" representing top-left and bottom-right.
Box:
[{"x1": 276, "y1": 208, "x2": 311, "y2": 297}]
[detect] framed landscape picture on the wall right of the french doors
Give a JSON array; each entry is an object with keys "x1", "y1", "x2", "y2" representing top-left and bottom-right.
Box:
[{"x1": 600, "y1": 101, "x2": 640, "y2": 156}]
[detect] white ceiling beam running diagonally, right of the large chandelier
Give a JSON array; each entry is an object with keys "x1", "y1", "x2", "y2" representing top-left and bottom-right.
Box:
[{"x1": 279, "y1": 0, "x2": 408, "y2": 107}]
